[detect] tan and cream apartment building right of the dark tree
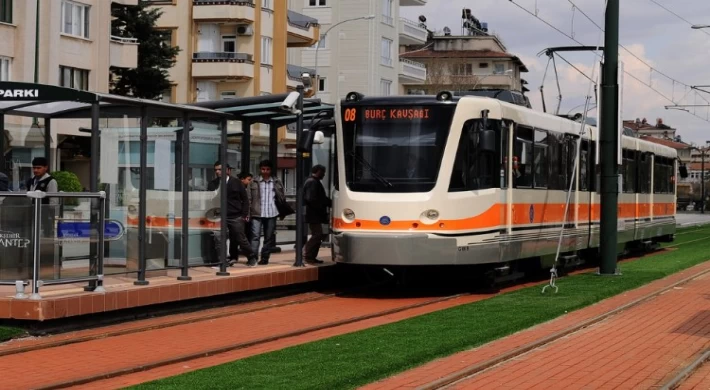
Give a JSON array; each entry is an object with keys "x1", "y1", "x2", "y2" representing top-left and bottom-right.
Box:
[{"x1": 152, "y1": 0, "x2": 319, "y2": 103}]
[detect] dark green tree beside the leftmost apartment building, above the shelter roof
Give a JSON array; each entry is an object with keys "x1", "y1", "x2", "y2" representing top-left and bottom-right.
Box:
[{"x1": 109, "y1": 0, "x2": 180, "y2": 99}]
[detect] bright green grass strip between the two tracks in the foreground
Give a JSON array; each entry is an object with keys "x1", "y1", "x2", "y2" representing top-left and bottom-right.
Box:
[{"x1": 134, "y1": 227, "x2": 710, "y2": 390}]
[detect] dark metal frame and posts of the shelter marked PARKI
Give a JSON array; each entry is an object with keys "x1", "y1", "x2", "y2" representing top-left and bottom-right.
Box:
[{"x1": 0, "y1": 82, "x2": 231, "y2": 291}]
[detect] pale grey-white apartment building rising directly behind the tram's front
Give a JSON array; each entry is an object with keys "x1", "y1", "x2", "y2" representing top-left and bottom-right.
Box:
[{"x1": 289, "y1": 0, "x2": 427, "y2": 103}]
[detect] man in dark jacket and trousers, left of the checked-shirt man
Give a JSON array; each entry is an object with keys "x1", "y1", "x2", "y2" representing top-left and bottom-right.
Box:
[{"x1": 207, "y1": 161, "x2": 256, "y2": 266}]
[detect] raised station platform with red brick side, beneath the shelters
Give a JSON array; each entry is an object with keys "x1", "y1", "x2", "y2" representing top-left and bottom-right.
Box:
[{"x1": 0, "y1": 251, "x2": 335, "y2": 321}]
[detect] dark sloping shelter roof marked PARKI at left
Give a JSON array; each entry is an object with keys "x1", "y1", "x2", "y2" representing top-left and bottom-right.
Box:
[{"x1": 0, "y1": 81, "x2": 228, "y2": 119}]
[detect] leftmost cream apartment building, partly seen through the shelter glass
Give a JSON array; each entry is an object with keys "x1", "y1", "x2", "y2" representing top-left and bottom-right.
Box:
[{"x1": 0, "y1": 0, "x2": 138, "y2": 186}]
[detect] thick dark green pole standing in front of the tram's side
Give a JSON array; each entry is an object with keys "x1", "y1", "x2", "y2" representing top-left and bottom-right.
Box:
[{"x1": 599, "y1": 0, "x2": 619, "y2": 275}]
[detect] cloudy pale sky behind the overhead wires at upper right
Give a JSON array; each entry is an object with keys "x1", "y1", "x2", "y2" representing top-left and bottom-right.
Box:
[{"x1": 400, "y1": 0, "x2": 710, "y2": 144}]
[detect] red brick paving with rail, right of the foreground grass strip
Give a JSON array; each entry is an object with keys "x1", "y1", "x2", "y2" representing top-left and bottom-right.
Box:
[{"x1": 363, "y1": 262, "x2": 710, "y2": 390}]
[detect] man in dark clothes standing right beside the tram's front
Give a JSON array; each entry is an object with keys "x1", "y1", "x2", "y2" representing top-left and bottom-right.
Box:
[{"x1": 303, "y1": 164, "x2": 332, "y2": 264}]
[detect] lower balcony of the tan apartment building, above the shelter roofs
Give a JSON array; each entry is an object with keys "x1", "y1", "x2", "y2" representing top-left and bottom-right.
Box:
[{"x1": 192, "y1": 52, "x2": 254, "y2": 81}]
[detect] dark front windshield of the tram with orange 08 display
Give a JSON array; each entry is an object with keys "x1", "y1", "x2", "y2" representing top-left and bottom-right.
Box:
[{"x1": 342, "y1": 105, "x2": 455, "y2": 193}]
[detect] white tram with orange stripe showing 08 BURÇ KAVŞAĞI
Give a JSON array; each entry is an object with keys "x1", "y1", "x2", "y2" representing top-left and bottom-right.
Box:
[{"x1": 332, "y1": 92, "x2": 677, "y2": 267}]
